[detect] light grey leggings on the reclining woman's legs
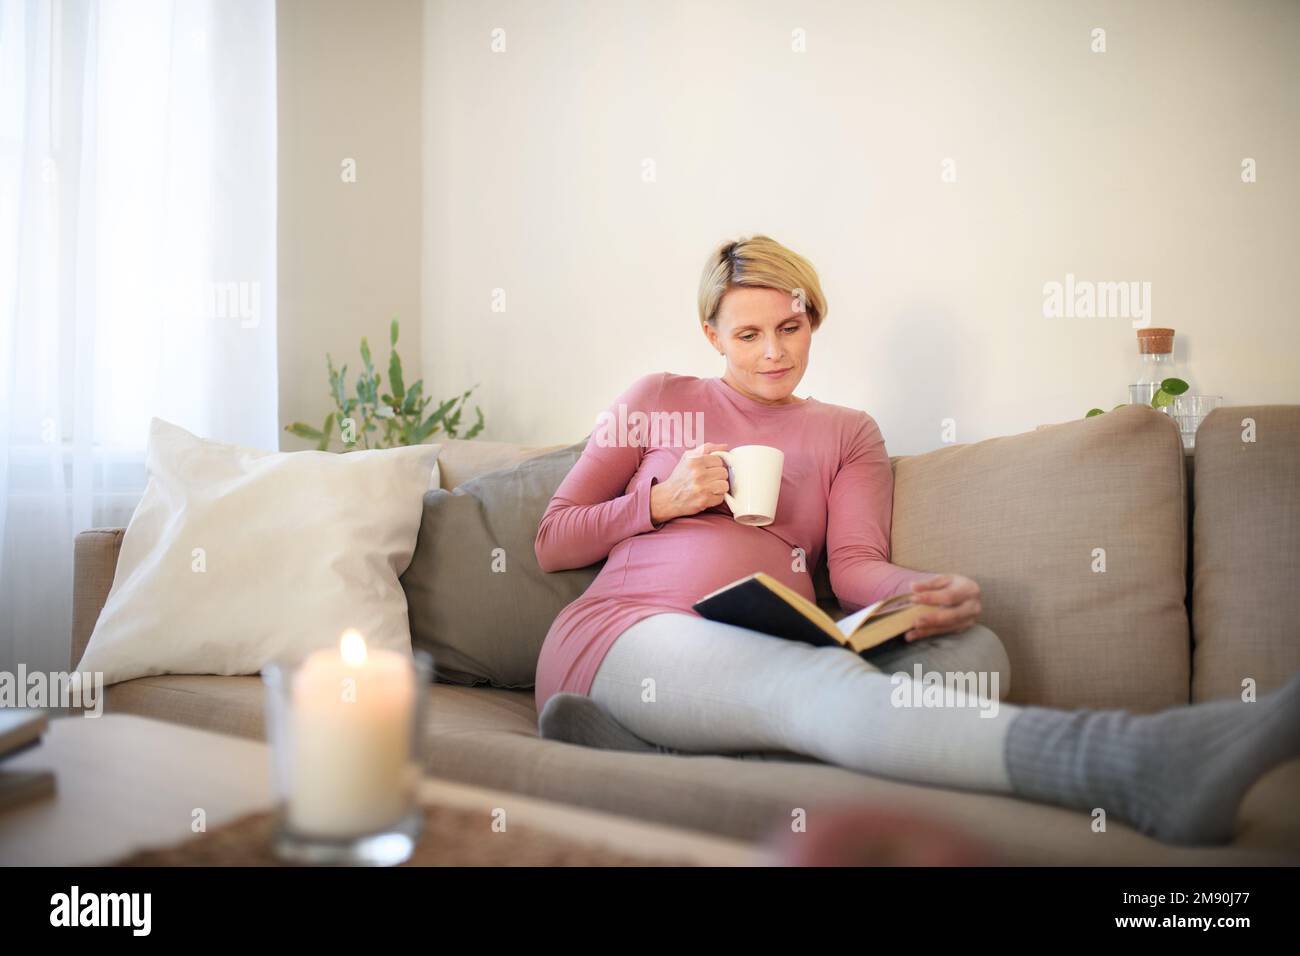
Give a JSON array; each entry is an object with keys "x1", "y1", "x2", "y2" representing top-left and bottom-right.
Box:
[{"x1": 590, "y1": 614, "x2": 1019, "y2": 792}]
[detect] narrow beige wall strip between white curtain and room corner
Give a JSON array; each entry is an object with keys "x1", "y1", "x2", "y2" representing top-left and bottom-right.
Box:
[{"x1": 277, "y1": 0, "x2": 423, "y2": 449}]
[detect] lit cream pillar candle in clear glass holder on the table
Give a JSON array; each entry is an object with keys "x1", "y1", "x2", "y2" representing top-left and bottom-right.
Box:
[{"x1": 263, "y1": 631, "x2": 433, "y2": 866}]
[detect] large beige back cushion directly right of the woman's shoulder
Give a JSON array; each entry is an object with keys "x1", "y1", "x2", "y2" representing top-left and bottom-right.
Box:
[{"x1": 891, "y1": 406, "x2": 1191, "y2": 711}]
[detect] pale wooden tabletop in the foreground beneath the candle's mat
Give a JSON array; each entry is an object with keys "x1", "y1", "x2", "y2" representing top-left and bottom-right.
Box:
[{"x1": 0, "y1": 714, "x2": 767, "y2": 866}]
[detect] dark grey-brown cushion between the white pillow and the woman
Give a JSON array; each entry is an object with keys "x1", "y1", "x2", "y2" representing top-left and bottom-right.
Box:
[{"x1": 402, "y1": 438, "x2": 605, "y2": 688}]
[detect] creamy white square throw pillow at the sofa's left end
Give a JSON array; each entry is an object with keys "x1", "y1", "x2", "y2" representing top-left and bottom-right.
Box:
[{"x1": 77, "y1": 419, "x2": 442, "y2": 684}]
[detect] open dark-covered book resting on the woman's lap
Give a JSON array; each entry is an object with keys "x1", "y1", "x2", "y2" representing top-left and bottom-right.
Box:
[{"x1": 692, "y1": 571, "x2": 933, "y2": 654}]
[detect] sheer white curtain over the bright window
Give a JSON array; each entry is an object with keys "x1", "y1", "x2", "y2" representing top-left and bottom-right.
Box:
[{"x1": 0, "y1": 0, "x2": 278, "y2": 671}]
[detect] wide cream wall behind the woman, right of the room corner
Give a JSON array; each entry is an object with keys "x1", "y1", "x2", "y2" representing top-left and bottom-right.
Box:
[{"x1": 421, "y1": 0, "x2": 1300, "y2": 454}]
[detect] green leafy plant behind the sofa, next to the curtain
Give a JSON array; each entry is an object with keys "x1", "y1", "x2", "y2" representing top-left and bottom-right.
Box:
[{"x1": 285, "y1": 319, "x2": 484, "y2": 451}]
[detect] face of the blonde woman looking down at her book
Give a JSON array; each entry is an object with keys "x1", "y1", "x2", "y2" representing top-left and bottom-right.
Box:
[{"x1": 705, "y1": 286, "x2": 813, "y2": 405}]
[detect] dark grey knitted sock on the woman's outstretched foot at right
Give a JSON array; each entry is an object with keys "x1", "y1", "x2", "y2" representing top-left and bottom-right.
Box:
[{"x1": 1005, "y1": 670, "x2": 1300, "y2": 844}]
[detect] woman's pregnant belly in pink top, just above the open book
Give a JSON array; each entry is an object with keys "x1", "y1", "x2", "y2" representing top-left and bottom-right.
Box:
[{"x1": 598, "y1": 511, "x2": 814, "y2": 609}]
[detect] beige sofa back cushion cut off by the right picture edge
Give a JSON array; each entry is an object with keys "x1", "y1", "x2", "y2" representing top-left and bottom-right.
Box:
[{"x1": 1192, "y1": 405, "x2": 1300, "y2": 701}]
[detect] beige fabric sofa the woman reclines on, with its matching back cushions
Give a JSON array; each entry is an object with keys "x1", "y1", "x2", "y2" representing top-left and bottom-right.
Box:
[{"x1": 72, "y1": 406, "x2": 1300, "y2": 865}]
